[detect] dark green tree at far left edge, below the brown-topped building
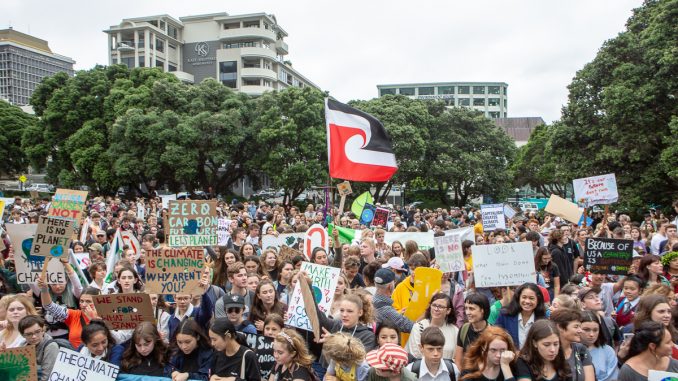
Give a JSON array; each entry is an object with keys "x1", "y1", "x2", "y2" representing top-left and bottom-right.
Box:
[{"x1": 0, "y1": 100, "x2": 37, "y2": 176}]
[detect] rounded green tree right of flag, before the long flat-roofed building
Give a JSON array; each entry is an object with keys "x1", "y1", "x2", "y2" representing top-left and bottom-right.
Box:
[{"x1": 423, "y1": 108, "x2": 516, "y2": 206}]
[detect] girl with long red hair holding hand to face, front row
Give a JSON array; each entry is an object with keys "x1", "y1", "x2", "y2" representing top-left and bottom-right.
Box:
[{"x1": 461, "y1": 327, "x2": 516, "y2": 381}]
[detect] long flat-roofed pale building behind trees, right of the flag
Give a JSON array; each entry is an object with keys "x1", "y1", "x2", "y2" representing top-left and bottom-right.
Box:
[{"x1": 377, "y1": 82, "x2": 508, "y2": 119}]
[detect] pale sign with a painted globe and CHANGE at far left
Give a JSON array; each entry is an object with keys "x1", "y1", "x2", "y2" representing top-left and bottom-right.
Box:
[{"x1": 5, "y1": 224, "x2": 66, "y2": 284}]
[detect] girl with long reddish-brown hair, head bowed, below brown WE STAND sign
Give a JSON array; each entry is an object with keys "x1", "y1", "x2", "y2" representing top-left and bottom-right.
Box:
[{"x1": 120, "y1": 322, "x2": 167, "y2": 376}]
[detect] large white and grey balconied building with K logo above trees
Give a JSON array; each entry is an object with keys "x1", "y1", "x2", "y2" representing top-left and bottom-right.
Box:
[{"x1": 104, "y1": 13, "x2": 317, "y2": 95}]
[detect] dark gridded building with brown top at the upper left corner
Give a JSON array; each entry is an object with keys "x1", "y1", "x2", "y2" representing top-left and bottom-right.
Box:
[{"x1": 0, "y1": 28, "x2": 75, "y2": 106}]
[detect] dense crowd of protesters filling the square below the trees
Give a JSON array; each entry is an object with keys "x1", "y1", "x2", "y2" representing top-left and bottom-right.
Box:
[{"x1": 0, "y1": 197, "x2": 678, "y2": 381}]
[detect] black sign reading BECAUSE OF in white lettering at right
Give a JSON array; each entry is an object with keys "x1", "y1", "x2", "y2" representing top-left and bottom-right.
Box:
[{"x1": 584, "y1": 238, "x2": 633, "y2": 275}]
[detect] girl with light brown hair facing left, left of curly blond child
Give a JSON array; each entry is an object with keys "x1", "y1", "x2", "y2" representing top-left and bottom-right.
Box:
[{"x1": 269, "y1": 328, "x2": 315, "y2": 381}]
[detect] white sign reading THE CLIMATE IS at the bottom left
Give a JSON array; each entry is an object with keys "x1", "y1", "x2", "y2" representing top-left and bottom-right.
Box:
[{"x1": 49, "y1": 348, "x2": 120, "y2": 381}]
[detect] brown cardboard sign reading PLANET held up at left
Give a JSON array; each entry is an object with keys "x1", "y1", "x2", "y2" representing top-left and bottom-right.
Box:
[{"x1": 31, "y1": 216, "x2": 73, "y2": 258}]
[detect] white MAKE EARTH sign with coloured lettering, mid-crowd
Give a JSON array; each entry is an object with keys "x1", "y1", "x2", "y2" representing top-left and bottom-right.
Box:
[{"x1": 285, "y1": 262, "x2": 341, "y2": 331}]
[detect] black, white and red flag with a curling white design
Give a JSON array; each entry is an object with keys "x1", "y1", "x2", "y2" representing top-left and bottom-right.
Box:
[{"x1": 325, "y1": 98, "x2": 398, "y2": 182}]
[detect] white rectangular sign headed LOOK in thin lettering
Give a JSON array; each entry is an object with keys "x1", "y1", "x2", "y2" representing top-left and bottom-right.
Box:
[{"x1": 471, "y1": 242, "x2": 537, "y2": 287}]
